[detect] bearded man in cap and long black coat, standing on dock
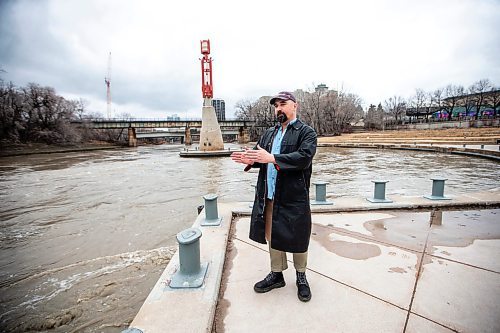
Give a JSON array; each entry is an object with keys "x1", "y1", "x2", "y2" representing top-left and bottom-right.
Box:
[{"x1": 231, "y1": 91, "x2": 317, "y2": 302}]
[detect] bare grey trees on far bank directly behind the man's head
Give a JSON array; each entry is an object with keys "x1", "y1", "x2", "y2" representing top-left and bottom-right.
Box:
[{"x1": 235, "y1": 85, "x2": 364, "y2": 140}]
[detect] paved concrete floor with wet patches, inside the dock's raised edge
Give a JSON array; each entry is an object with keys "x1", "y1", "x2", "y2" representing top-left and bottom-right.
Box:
[{"x1": 218, "y1": 209, "x2": 500, "y2": 332}]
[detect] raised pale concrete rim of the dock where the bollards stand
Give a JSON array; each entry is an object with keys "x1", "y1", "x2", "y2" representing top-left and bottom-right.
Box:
[{"x1": 124, "y1": 188, "x2": 500, "y2": 333}]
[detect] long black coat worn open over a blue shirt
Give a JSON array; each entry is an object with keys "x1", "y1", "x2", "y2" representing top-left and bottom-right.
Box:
[{"x1": 250, "y1": 120, "x2": 318, "y2": 253}]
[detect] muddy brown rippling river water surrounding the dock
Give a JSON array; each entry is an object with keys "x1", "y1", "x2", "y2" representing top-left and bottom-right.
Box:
[{"x1": 0, "y1": 145, "x2": 500, "y2": 332}]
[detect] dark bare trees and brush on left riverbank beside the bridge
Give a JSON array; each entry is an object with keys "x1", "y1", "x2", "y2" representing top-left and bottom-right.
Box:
[{"x1": 0, "y1": 80, "x2": 120, "y2": 144}]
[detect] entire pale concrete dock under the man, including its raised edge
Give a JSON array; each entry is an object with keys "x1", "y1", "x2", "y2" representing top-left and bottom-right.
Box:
[{"x1": 126, "y1": 189, "x2": 500, "y2": 333}]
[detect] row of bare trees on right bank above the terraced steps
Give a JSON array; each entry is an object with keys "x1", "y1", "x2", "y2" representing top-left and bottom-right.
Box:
[{"x1": 364, "y1": 79, "x2": 500, "y2": 129}]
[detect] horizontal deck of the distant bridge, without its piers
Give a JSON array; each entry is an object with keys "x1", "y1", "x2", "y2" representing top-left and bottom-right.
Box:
[{"x1": 71, "y1": 118, "x2": 255, "y2": 129}]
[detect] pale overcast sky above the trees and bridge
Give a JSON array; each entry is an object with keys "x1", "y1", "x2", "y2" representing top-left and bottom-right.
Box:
[{"x1": 0, "y1": 0, "x2": 500, "y2": 118}]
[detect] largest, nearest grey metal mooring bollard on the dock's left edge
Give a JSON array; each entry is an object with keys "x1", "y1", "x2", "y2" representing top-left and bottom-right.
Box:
[{"x1": 169, "y1": 228, "x2": 208, "y2": 288}]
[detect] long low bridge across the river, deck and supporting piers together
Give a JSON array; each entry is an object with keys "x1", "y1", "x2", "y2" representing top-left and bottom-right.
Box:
[{"x1": 71, "y1": 118, "x2": 255, "y2": 147}]
